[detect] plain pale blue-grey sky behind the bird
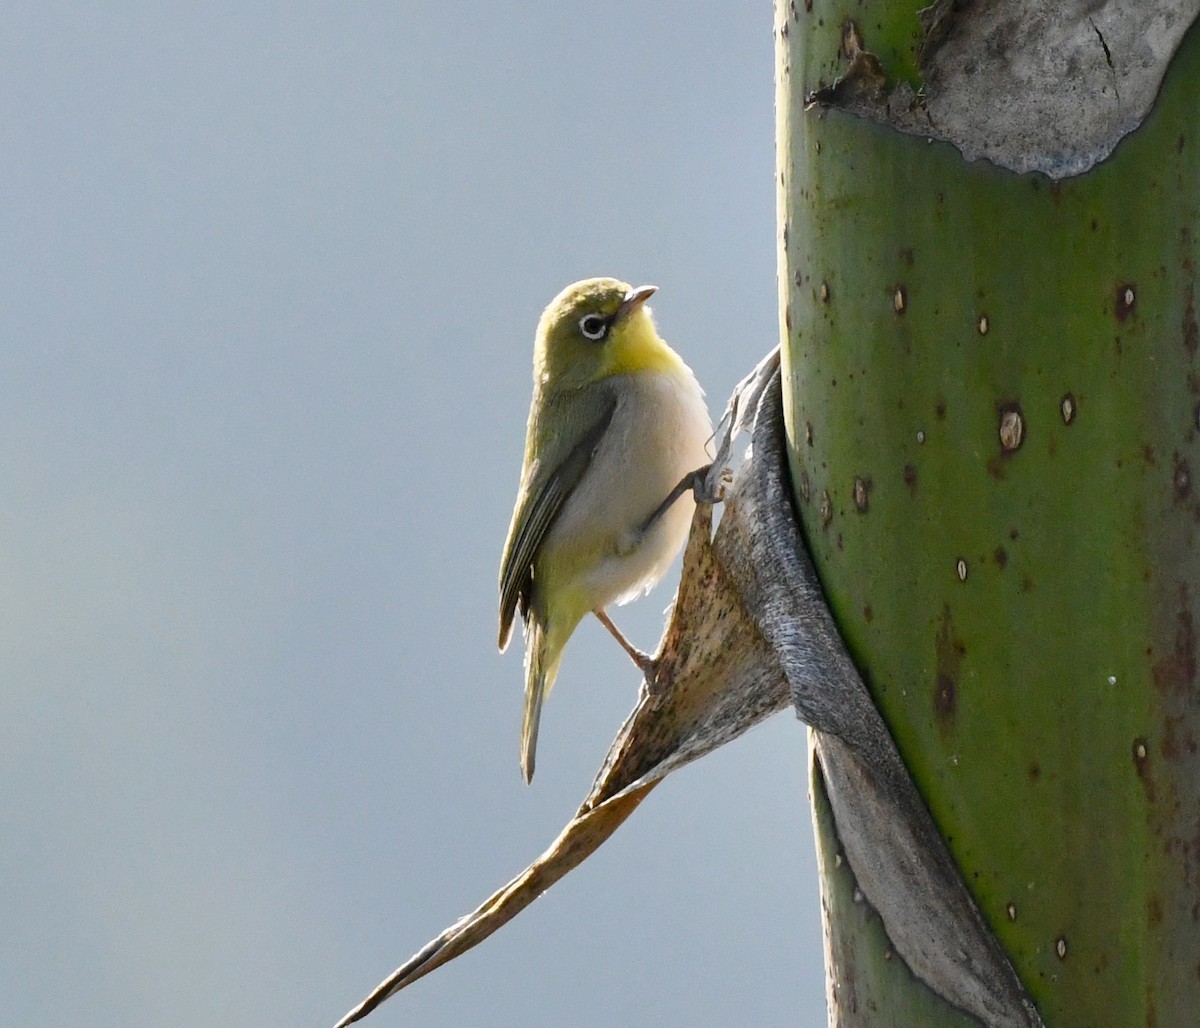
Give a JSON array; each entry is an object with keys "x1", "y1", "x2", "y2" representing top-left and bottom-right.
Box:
[{"x1": 0, "y1": 0, "x2": 824, "y2": 1028}]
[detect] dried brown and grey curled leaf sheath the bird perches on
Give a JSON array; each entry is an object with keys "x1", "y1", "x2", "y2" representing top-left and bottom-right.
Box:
[{"x1": 337, "y1": 356, "x2": 1042, "y2": 1028}]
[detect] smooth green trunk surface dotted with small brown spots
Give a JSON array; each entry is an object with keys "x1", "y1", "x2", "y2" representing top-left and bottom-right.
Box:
[{"x1": 776, "y1": 0, "x2": 1200, "y2": 1028}]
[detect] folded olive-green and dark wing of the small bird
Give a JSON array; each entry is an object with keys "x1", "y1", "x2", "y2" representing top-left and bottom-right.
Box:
[{"x1": 499, "y1": 386, "x2": 617, "y2": 650}]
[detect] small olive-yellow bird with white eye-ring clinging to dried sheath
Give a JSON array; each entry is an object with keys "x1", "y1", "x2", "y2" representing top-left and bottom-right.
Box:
[{"x1": 499, "y1": 278, "x2": 713, "y2": 782}]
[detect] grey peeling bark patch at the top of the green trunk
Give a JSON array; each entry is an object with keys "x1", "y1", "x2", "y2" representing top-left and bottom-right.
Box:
[{"x1": 809, "y1": 0, "x2": 1200, "y2": 179}]
